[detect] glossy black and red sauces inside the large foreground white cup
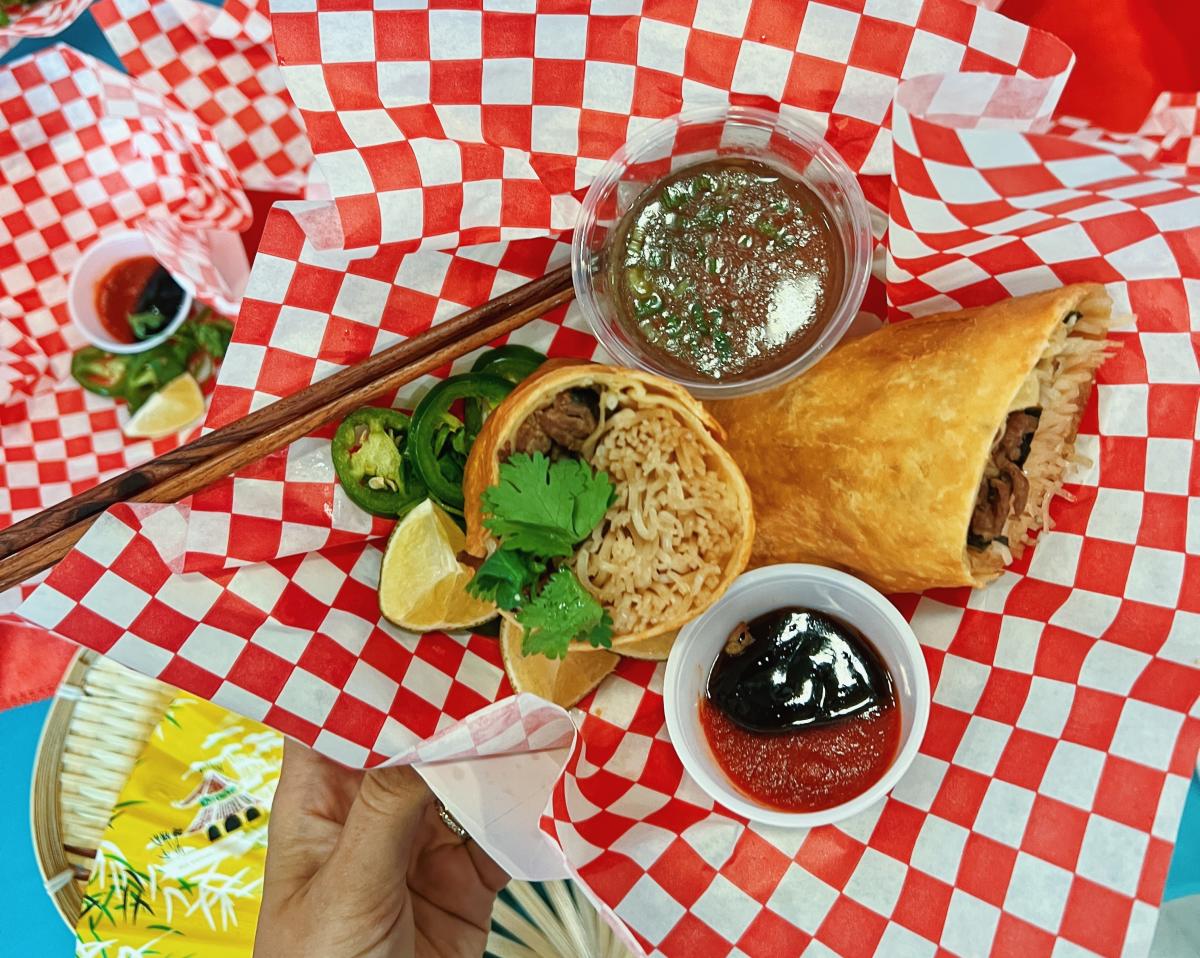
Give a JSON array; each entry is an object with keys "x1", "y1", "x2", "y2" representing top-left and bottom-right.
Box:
[{"x1": 700, "y1": 607, "x2": 900, "y2": 812}]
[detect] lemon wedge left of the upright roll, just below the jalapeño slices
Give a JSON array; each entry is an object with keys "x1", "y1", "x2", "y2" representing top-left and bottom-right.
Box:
[{"x1": 379, "y1": 499, "x2": 496, "y2": 633}]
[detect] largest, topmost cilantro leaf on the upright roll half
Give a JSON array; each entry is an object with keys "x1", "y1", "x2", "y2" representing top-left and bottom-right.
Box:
[{"x1": 484, "y1": 453, "x2": 616, "y2": 558}]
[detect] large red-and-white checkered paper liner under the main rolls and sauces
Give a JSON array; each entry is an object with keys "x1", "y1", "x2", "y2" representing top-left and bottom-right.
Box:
[{"x1": 11, "y1": 0, "x2": 1200, "y2": 958}]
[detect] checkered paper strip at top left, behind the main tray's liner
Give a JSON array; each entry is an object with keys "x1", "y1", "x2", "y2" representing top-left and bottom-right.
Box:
[{"x1": 91, "y1": 0, "x2": 312, "y2": 193}]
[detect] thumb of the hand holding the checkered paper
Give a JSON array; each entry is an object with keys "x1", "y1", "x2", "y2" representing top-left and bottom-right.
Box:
[{"x1": 325, "y1": 766, "x2": 433, "y2": 904}]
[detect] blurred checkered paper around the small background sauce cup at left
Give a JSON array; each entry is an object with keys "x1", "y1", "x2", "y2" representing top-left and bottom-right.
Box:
[{"x1": 0, "y1": 46, "x2": 250, "y2": 611}]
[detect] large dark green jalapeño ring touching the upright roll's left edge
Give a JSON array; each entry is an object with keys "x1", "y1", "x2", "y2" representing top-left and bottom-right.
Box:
[{"x1": 408, "y1": 372, "x2": 512, "y2": 511}]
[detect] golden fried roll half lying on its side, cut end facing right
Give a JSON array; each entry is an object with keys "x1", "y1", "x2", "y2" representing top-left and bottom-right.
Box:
[{"x1": 710, "y1": 283, "x2": 1112, "y2": 592}]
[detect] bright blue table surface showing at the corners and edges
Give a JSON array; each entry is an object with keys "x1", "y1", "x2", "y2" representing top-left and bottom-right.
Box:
[{"x1": 0, "y1": 9, "x2": 1200, "y2": 958}]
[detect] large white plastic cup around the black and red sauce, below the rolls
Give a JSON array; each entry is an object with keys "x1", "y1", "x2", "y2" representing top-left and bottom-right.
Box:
[{"x1": 662, "y1": 564, "x2": 930, "y2": 828}]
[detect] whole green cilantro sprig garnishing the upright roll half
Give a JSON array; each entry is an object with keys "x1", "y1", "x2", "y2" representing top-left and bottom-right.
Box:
[{"x1": 467, "y1": 453, "x2": 617, "y2": 658}]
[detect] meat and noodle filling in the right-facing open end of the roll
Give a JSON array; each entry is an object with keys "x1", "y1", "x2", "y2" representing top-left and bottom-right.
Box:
[{"x1": 967, "y1": 289, "x2": 1110, "y2": 574}]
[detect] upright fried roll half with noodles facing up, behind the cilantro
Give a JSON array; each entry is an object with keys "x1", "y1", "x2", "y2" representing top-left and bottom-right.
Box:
[{"x1": 463, "y1": 361, "x2": 754, "y2": 658}]
